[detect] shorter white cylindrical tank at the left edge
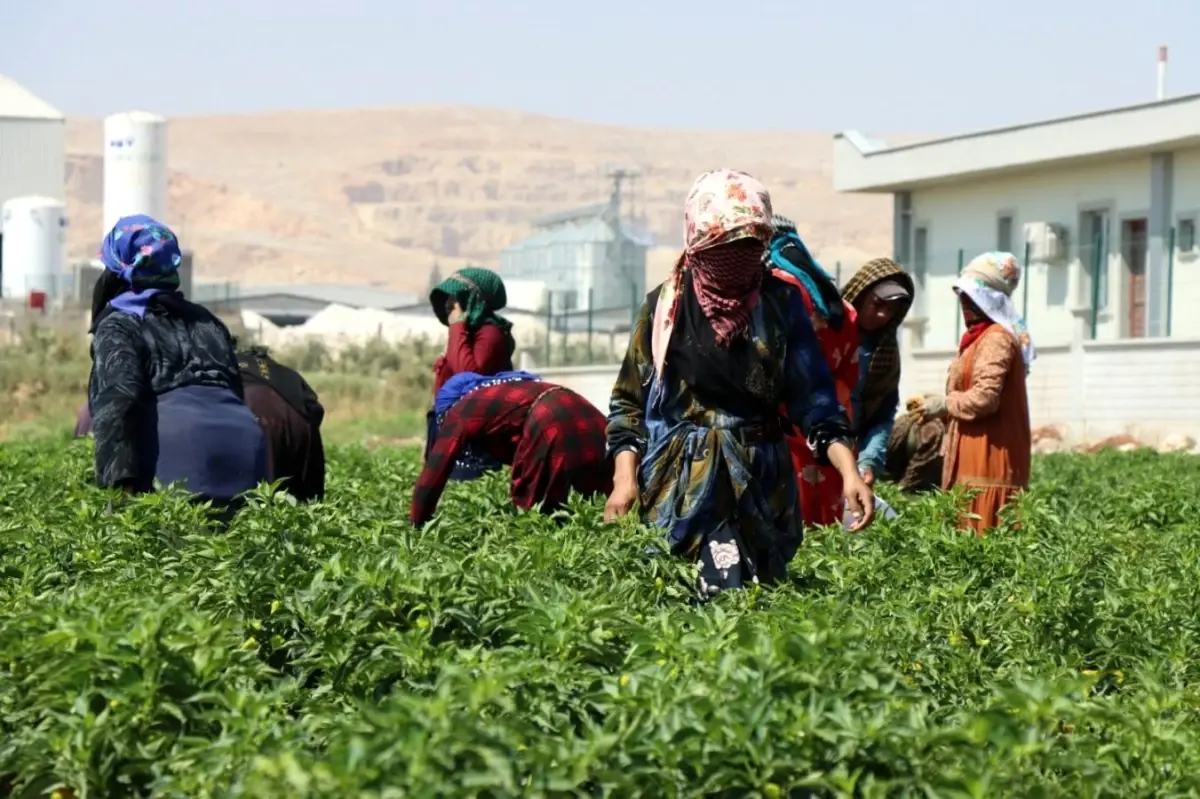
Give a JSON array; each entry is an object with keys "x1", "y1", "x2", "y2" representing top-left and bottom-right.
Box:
[{"x1": 0, "y1": 197, "x2": 67, "y2": 300}]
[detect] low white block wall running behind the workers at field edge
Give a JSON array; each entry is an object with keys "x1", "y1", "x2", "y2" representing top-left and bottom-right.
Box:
[{"x1": 535, "y1": 338, "x2": 1200, "y2": 445}]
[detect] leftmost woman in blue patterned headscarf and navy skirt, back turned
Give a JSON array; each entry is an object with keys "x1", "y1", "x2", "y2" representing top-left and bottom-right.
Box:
[{"x1": 88, "y1": 216, "x2": 266, "y2": 505}]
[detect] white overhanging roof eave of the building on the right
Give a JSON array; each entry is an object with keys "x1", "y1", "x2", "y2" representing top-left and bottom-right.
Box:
[{"x1": 834, "y1": 94, "x2": 1200, "y2": 193}]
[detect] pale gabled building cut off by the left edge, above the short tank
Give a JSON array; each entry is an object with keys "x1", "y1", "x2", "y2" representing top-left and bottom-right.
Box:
[{"x1": 0, "y1": 74, "x2": 66, "y2": 257}]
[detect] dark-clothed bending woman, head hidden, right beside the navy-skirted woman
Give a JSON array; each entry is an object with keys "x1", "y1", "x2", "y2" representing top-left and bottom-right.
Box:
[{"x1": 238, "y1": 347, "x2": 325, "y2": 501}]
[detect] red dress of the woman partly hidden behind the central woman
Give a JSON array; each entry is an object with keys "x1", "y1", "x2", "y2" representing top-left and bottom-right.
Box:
[{"x1": 772, "y1": 269, "x2": 858, "y2": 527}]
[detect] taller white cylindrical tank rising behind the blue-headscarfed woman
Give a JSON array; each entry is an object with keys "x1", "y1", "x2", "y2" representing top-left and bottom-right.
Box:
[{"x1": 100, "y1": 112, "x2": 168, "y2": 236}]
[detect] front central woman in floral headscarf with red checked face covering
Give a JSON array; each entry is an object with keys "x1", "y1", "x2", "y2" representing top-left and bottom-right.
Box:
[{"x1": 605, "y1": 169, "x2": 874, "y2": 595}]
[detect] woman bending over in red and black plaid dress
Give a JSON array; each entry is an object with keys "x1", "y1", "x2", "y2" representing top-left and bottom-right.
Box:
[{"x1": 409, "y1": 372, "x2": 612, "y2": 525}]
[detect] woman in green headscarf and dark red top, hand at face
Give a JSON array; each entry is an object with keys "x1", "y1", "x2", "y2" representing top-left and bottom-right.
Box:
[{"x1": 425, "y1": 266, "x2": 516, "y2": 480}]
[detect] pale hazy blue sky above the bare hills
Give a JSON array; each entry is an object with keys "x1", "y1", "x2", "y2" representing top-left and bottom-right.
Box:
[{"x1": 0, "y1": 0, "x2": 1200, "y2": 133}]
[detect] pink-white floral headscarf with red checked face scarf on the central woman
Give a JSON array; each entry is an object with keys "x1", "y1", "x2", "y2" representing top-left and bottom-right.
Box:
[{"x1": 652, "y1": 169, "x2": 774, "y2": 373}]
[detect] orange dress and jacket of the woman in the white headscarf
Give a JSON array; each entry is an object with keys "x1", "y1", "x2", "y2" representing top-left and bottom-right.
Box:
[{"x1": 942, "y1": 324, "x2": 1033, "y2": 535}]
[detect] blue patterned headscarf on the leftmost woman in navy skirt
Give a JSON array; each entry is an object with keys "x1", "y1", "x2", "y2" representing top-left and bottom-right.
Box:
[{"x1": 100, "y1": 214, "x2": 184, "y2": 317}]
